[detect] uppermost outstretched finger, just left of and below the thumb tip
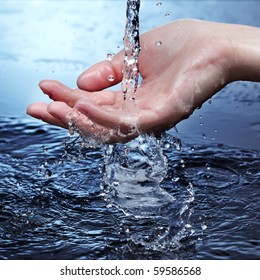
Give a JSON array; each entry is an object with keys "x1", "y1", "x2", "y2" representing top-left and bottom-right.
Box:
[{"x1": 39, "y1": 80, "x2": 84, "y2": 107}]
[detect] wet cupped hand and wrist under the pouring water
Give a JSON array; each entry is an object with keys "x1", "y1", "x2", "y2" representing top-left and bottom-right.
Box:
[{"x1": 27, "y1": 20, "x2": 260, "y2": 143}]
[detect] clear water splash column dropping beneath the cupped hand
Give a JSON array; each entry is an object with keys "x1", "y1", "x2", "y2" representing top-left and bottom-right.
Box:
[{"x1": 103, "y1": 135, "x2": 171, "y2": 217}]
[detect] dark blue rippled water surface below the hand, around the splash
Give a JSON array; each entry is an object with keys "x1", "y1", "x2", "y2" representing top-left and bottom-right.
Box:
[{"x1": 0, "y1": 118, "x2": 260, "y2": 259}]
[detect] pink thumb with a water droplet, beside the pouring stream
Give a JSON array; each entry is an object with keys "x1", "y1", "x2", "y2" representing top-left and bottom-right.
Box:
[{"x1": 77, "y1": 51, "x2": 124, "y2": 91}]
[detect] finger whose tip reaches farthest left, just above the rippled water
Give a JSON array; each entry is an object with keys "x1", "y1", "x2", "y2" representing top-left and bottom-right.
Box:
[{"x1": 26, "y1": 102, "x2": 67, "y2": 128}]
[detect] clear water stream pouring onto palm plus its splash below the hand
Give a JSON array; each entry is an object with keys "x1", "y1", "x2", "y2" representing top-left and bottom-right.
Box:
[{"x1": 99, "y1": 0, "x2": 194, "y2": 250}]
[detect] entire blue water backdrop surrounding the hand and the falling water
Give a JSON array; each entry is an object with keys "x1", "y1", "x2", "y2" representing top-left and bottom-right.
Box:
[{"x1": 0, "y1": 0, "x2": 260, "y2": 259}]
